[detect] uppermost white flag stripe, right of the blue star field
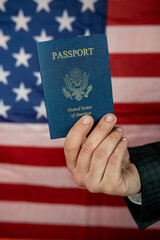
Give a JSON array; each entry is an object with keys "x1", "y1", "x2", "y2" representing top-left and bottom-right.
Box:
[{"x1": 106, "y1": 25, "x2": 160, "y2": 53}]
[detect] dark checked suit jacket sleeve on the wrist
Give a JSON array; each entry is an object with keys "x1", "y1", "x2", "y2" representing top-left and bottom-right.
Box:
[{"x1": 124, "y1": 142, "x2": 160, "y2": 229}]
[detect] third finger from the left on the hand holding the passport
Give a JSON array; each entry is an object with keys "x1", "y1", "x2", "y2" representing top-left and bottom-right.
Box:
[{"x1": 87, "y1": 127, "x2": 123, "y2": 186}]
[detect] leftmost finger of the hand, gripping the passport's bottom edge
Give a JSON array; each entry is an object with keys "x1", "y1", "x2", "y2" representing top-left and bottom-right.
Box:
[{"x1": 64, "y1": 115, "x2": 94, "y2": 172}]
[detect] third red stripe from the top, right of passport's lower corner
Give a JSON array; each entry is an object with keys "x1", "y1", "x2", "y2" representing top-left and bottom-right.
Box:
[{"x1": 114, "y1": 103, "x2": 160, "y2": 124}]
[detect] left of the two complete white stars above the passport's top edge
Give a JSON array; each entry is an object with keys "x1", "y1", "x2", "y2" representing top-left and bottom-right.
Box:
[{"x1": 11, "y1": 10, "x2": 32, "y2": 31}]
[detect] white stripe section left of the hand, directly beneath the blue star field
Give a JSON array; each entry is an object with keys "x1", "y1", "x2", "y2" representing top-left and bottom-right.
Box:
[{"x1": 0, "y1": 123, "x2": 64, "y2": 148}]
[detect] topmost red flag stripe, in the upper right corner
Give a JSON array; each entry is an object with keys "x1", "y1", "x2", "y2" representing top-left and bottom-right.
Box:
[{"x1": 107, "y1": 0, "x2": 160, "y2": 25}]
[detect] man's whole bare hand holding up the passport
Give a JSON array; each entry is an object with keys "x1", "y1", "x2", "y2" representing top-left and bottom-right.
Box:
[{"x1": 64, "y1": 114, "x2": 141, "y2": 196}]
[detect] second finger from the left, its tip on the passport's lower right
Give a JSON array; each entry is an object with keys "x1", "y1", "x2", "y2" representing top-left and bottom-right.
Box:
[{"x1": 76, "y1": 113, "x2": 117, "y2": 175}]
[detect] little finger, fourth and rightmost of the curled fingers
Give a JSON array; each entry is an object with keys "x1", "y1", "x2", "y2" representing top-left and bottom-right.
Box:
[{"x1": 101, "y1": 138, "x2": 128, "y2": 195}]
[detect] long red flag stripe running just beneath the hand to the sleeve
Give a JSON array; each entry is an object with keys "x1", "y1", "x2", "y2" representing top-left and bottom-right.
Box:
[{"x1": 0, "y1": 184, "x2": 126, "y2": 206}]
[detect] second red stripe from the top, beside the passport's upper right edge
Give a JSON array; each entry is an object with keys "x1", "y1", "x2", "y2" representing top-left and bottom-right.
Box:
[{"x1": 109, "y1": 54, "x2": 160, "y2": 77}]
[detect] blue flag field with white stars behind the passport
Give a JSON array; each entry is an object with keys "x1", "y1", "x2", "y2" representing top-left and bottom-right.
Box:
[{"x1": 0, "y1": 0, "x2": 107, "y2": 123}]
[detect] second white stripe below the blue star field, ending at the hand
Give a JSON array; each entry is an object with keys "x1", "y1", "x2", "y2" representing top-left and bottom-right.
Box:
[{"x1": 0, "y1": 163, "x2": 77, "y2": 188}]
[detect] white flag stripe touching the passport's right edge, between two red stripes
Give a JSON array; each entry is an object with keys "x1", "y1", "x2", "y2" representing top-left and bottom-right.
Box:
[{"x1": 112, "y1": 77, "x2": 160, "y2": 103}]
